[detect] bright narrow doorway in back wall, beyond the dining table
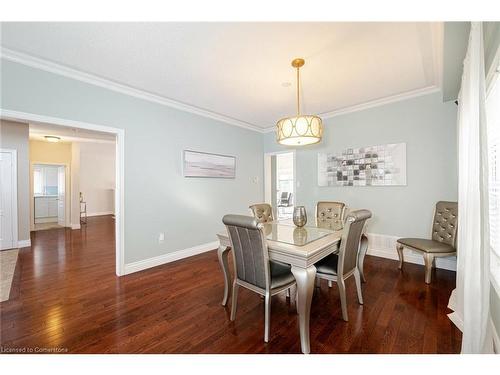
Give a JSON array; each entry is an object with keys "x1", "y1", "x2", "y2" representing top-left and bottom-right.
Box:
[{"x1": 264, "y1": 151, "x2": 297, "y2": 220}]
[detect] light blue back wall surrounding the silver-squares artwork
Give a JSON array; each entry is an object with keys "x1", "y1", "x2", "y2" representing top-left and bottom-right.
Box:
[{"x1": 264, "y1": 93, "x2": 458, "y2": 237}]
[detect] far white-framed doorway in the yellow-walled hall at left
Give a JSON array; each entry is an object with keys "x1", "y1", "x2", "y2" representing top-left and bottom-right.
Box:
[{"x1": 32, "y1": 163, "x2": 67, "y2": 231}]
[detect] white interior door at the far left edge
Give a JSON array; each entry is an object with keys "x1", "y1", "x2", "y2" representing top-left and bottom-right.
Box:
[{"x1": 0, "y1": 152, "x2": 15, "y2": 250}]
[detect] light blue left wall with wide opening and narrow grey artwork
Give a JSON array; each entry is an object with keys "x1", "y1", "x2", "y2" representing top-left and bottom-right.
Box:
[{"x1": 1, "y1": 60, "x2": 263, "y2": 263}]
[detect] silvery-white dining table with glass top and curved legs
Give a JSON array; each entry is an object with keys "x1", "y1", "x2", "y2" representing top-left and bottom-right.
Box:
[{"x1": 217, "y1": 220, "x2": 342, "y2": 354}]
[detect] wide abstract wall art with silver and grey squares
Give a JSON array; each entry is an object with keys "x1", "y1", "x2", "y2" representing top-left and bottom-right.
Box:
[{"x1": 318, "y1": 143, "x2": 406, "y2": 186}]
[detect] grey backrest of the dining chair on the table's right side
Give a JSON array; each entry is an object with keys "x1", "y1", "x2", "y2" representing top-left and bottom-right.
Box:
[{"x1": 337, "y1": 210, "x2": 372, "y2": 277}]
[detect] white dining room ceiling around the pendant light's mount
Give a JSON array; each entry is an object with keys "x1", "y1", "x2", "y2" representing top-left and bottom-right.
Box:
[{"x1": 1, "y1": 22, "x2": 443, "y2": 129}]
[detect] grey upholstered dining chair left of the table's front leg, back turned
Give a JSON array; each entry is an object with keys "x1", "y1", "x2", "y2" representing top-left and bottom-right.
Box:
[{"x1": 222, "y1": 215, "x2": 295, "y2": 342}]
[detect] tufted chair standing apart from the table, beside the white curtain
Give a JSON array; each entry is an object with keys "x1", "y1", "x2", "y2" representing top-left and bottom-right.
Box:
[{"x1": 396, "y1": 201, "x2": 458, "y2": 284}]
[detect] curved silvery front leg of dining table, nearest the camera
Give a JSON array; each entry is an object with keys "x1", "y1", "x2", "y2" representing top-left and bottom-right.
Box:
[{"x1": 292, "y1": 266, "x2": 316, "y2": 354}]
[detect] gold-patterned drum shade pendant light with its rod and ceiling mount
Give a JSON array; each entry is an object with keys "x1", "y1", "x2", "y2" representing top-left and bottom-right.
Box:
[{"x1": 276, "y1": 58, "x2": 323, "y2": 146}]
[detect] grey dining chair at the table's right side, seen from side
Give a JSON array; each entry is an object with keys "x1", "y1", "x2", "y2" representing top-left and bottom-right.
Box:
[{"x1": 316, "y1": 210, "x2": 372, "y2": 322}]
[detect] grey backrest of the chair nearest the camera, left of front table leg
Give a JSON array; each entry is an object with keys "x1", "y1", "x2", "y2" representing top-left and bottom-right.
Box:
[{"x1": 222, "y1": 215, "x2": 271, "y2": 289}]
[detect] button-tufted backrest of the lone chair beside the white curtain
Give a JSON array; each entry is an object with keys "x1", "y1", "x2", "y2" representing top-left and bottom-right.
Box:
[{"x1": 432, "y1": 201, "x2": 458, "y2": 248}]
